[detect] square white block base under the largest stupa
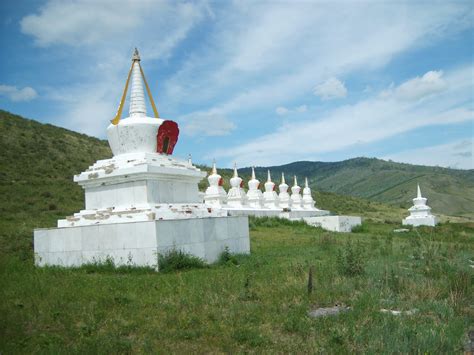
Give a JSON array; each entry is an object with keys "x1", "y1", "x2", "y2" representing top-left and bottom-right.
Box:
[{"x1": 34, "y1": 217, "x2": 250, "y2": 271}]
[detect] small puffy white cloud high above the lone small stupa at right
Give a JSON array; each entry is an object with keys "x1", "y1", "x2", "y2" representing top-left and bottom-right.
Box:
[{"x1": 381, "y1": 70, "x2": 446, "y2": 100}]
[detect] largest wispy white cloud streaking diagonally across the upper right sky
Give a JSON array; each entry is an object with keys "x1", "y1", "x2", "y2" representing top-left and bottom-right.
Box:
[{"x1": 164, "y1": 2, "x2": 472, "y2": 114}]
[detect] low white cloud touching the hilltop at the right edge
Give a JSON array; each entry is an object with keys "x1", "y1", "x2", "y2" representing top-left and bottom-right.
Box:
[{"x1": 383, "y1": 139, "x2": 474, "y2": 169}]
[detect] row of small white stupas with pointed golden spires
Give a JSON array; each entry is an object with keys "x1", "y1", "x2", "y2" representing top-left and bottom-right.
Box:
[{"x1": 204, "y1": 163, "x2": 318, "y2": 211}]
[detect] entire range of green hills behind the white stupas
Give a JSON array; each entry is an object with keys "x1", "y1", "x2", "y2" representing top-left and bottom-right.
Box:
[{"x1": 0, "y1": 110, "x2": 474, "y2": 221}]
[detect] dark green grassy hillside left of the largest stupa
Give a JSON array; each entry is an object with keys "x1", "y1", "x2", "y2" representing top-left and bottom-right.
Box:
[{"x1": 0, "y1": 111, "x2": 112, "y2": 258}]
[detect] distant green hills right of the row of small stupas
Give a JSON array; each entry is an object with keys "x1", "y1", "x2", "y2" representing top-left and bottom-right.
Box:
[{"x1": 242, "y1": 158, "x2": 474, "y2": 218}]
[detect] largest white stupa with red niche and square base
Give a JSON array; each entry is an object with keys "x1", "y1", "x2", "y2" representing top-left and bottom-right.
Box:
[{"x1": 34, "y1": 50, "x2": 250, "y2": 267}]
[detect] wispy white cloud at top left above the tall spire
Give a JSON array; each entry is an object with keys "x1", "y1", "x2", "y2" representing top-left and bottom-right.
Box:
[{"x1": 20, "y1": 0, "x2": 206, "y2": 58}]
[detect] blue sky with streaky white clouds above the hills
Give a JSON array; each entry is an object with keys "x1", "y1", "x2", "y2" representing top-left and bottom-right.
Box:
[{"x1": 0, "y1": 0, "x2": 474, "y2": 169}]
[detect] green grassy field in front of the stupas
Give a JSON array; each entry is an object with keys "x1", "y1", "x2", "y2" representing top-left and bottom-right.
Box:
[{"x1": 0, "y1": 219, "x2": 474, "y2": 353}]
